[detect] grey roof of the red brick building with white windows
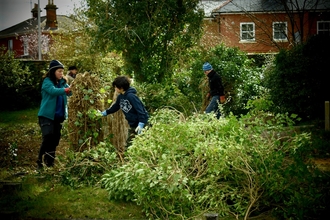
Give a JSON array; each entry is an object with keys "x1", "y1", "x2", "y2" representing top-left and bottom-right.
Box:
[{"x1": 212, "y1": 0, "x2": 330, "y2": 14}]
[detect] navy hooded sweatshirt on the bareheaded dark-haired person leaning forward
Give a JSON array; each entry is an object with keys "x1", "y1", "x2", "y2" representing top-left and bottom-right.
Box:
[{"x1": 106, "y1": 87, "x2": 149, "y2": 127}]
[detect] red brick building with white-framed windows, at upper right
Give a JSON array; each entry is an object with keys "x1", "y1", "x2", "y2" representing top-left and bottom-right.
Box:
[{"x1": 201, "y1": 0, "x2": 330, "y2": 54}]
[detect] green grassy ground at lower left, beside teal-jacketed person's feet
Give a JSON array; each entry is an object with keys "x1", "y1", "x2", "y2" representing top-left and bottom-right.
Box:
[{"x1": 0, "y1": 109, "x2": 146, "y2": 219}]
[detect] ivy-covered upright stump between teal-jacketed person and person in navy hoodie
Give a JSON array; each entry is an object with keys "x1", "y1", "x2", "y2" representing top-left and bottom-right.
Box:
[{"x1": 68, "y1": 73, "x2": 105, "y2": 151}]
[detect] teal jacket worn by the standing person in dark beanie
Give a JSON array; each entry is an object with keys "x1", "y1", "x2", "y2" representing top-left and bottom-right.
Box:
[{"x1": 38, "y1": 77, "x2": 71, "y2": 120}]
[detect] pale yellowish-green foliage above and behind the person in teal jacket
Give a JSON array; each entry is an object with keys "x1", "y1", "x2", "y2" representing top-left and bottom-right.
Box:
[{"x1": 48, "y1": 7, "x2": 124, "y2": 83}]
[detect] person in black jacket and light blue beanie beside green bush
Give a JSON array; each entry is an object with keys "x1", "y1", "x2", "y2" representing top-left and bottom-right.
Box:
[{"x1": 203, "y1": 62, "x2": 225, "y2": 119}]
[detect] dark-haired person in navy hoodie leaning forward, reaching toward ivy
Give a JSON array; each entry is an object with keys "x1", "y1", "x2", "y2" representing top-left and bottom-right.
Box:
[{"x1": 102, "y1": 76, "x2": 149, "y2": 148}]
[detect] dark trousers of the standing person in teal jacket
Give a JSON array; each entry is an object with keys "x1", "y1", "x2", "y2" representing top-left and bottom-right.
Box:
[{"x1": 37, "y1": 117, "x2": 63, "y2": 167}]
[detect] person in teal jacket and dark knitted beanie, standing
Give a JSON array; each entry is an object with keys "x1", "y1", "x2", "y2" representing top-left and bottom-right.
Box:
[{"x1": 37, "y1": 60, "x2": 71, "y2": 169}]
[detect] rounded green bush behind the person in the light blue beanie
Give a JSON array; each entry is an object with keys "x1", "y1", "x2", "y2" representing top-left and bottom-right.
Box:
[{"x1": 186, "y1": 45, "x2": 263, "y2": 115}]
